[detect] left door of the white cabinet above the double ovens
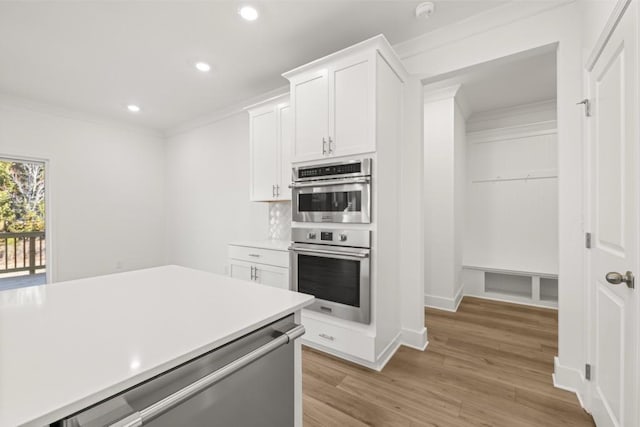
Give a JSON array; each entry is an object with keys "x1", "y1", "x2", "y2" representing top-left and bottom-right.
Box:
[{"x1": 291, "y1": 69, "x2": 329, "y2": 162}]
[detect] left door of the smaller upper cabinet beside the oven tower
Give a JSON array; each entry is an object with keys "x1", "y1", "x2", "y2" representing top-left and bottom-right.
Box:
[{"x1": 249, "y1": 107, "x2": 280, "y2": 202}]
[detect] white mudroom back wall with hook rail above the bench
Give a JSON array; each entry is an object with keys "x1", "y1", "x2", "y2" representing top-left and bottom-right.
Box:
[{"x1": 464, "y1": 105, "x2": 558, "y2": 274}]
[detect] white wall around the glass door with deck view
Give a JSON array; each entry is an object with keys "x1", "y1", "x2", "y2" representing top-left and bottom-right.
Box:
[{"x1": 0, "y1": 101, "x2": 165, "y2": 281}]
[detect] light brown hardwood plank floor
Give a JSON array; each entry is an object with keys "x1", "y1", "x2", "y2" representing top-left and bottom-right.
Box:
[{"x1": 302, "y1": 297, "x2": 594, "y2": 427}]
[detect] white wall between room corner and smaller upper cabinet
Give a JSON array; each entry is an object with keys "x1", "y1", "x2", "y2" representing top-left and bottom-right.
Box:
[{"x1": 164, "y1": 112, "x2": 269, "y2": 274}]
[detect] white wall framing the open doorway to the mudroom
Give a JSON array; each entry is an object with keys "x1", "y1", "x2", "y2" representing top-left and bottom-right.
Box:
[{"x1": 396, "y1": 2, "x2": 586, "y2": 402}]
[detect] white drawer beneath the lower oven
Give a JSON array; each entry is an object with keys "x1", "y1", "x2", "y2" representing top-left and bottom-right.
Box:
[{"x1": 302, "y1": 310, "x2": 376, "y2": 362}]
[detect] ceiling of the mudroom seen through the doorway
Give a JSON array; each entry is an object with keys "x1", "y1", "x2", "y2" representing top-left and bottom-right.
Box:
[{"x1": 423, "y1": 45, "x2": 557, "y2": 117}]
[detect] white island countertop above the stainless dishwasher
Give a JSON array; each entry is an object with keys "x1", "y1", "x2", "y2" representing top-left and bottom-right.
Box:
[{"x1": 0, "y1": 266, "x2": 313, "y2": 427}]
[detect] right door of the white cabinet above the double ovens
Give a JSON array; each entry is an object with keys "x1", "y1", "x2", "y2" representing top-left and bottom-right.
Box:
[{"x1": 329, "y1": 54, "x2": 376, "y2": 156}]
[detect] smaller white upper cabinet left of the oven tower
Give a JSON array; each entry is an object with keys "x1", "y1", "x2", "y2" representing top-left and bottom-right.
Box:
[{"x1": 248, "y1": 96, "x2": 292, "y2": 202}]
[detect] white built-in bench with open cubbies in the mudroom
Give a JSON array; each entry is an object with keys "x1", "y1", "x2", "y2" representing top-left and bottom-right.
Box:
[{"x1": 462, "y1": 265, "x2": 558, "y2": 308}]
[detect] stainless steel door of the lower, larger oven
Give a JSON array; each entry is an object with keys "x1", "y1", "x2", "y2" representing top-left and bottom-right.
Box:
[{"x1": 289, "y1": 243, "x2": 371, "y2": 324}]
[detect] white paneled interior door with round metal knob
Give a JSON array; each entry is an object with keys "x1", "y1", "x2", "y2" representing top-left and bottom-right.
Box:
[{"x1": 588, "y1": 1, "x2": 640, "y2": 427}]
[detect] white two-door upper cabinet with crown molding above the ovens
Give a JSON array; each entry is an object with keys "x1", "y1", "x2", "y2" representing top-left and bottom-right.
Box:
[{"x1": 283, "y1": 36, "x2": 404, "y2": 163}]
